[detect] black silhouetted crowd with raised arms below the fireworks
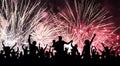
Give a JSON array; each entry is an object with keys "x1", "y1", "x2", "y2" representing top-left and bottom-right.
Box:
[{"x1": 0, "y1": 34, "x2": 120, "y2": 64}]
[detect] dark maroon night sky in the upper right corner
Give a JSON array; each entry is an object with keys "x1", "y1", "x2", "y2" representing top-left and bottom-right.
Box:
[{"x1": 104, "y1": 0, "x2": 120, "y2": 34}]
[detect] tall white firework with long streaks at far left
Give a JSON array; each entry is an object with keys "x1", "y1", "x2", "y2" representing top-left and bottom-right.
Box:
[{"x1": 0, "y1": 0, "x2": 47, "y2": 48}]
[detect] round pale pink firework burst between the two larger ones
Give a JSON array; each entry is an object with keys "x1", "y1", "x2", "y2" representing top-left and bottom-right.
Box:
[{"x1": 32, "y1": 13, "x2": 64, "y2": 47}]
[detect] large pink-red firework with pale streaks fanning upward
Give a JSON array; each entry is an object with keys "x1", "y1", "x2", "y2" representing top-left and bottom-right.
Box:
[{"x1": 58, "y1": 0, "x2": 119, "y2": 52}]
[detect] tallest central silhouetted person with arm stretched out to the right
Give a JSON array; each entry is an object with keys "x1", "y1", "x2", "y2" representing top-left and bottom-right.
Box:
[{"x1": 53, "y1": 36, "x2": 73, "y2": 63}]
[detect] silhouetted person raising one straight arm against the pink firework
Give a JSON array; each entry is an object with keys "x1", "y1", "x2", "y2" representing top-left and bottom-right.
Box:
[{"x1": 82, "y1": 34, "x2": 96, "y2": 59}]
